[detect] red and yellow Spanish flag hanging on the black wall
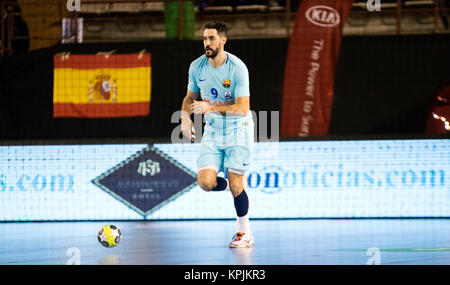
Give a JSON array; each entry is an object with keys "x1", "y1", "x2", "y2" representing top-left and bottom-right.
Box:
[{"x1": 53, "y1": 52, "x2": 151, "y2": 118}]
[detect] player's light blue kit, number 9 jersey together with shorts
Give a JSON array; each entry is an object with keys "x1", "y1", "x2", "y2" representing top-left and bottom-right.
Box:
[{"x1": 188, "y1": 52, "x2": 254, "y2": 171}]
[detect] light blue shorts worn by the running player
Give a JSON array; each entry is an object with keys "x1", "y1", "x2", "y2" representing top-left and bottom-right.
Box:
[{"x1": 197, "y1": 112, "x2": 254, "y2": 172}]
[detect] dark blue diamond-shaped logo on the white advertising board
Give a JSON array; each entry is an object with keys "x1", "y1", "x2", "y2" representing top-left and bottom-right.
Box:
[{"x1": 92, "y1": 146, "x2": 197, "y2": 217}]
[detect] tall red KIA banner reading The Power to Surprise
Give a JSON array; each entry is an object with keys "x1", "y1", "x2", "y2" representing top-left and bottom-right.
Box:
[{"x1": 281, "y1": 0, "x2": 353, "y2": 137}]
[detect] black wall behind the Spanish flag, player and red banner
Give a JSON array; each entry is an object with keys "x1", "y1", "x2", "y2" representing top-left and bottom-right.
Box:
[{"x1": 0, "y1": 34, "x2": 450, "y2": 140}]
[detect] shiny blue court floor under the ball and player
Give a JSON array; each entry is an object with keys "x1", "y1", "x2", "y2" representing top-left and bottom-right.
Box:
[{"x1": 0, "y1": 219, "x2": 450, "y2": 265}]
